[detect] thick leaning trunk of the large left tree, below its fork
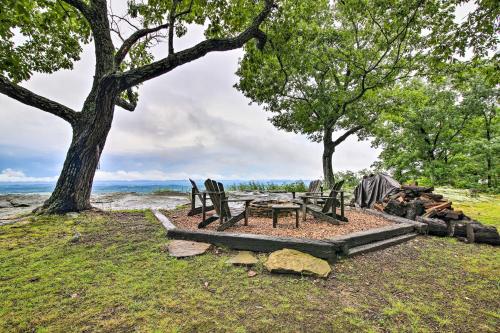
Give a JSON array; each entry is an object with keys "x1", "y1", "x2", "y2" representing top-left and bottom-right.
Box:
[{"x1": 40, "y1": 93, "x2": 116, "y2": 214}]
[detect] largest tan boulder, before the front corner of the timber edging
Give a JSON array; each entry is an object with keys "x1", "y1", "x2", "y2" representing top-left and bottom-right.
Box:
[{"x1": 264, "y1": 249, "x2": 332, "y2": 277}]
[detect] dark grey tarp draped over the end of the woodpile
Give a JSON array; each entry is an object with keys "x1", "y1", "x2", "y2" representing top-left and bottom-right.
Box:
[{"x1": 354, "y1": 173, "x2": 401, "y2": 208}]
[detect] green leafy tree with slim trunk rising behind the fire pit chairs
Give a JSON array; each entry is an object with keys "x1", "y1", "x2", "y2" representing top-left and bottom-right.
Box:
[{"x1": 237, "y1": 0, "x2": 440, "y2": 185}]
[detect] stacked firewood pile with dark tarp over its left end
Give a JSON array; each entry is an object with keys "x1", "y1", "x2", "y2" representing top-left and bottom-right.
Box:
[{"x1": 354, "y1": 174, "x2": 500, "y2": 245}]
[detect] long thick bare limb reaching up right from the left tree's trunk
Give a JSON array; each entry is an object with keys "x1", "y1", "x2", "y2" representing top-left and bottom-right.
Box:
[{"x1": 114, "y1": 0, "x2": 274, "y2": 90}]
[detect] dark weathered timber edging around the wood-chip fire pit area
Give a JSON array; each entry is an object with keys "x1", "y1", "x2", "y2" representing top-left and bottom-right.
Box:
[{"x1": 152, "y1": 209, "x2": 422, "y2": 262}]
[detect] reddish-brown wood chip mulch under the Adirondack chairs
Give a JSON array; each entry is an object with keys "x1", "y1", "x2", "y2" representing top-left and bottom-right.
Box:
[{"x1": 164, "y1": 209, "x2": 394, "y2": 239}]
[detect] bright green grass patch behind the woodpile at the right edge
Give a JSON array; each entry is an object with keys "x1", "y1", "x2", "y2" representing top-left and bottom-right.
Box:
[{"x1": 434, "y1": 188, "x2": 500, "y2": 228}]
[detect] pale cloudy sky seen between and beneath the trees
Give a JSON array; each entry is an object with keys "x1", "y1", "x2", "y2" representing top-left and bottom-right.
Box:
[{"x1": 0, "y1": 14, "x2": 378, "y2": 181}]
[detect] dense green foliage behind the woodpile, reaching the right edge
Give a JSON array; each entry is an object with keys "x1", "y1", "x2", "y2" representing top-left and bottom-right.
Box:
[{"x1": 374, "y1": 63, "x2": 500, "y2": 188}]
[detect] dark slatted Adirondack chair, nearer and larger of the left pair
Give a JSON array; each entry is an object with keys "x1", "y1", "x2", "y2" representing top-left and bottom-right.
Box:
[{"x1": 198, "y1": 179, "x2": 253, "y2": 231}]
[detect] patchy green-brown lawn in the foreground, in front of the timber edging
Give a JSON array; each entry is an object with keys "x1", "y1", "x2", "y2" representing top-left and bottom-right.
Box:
[{"x1": 0, "y1": 211, "x2": 500, "y2": 332}]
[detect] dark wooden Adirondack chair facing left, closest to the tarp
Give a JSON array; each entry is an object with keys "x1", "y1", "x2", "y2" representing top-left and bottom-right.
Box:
[{"x1": 301, "y1": 180, "x2": 347, "y2": 224}]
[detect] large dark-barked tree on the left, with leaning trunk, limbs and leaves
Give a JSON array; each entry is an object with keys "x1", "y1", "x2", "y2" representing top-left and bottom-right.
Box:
[{"x1": 0, "y1": 0, "x2": 274, "y2": 213}]
